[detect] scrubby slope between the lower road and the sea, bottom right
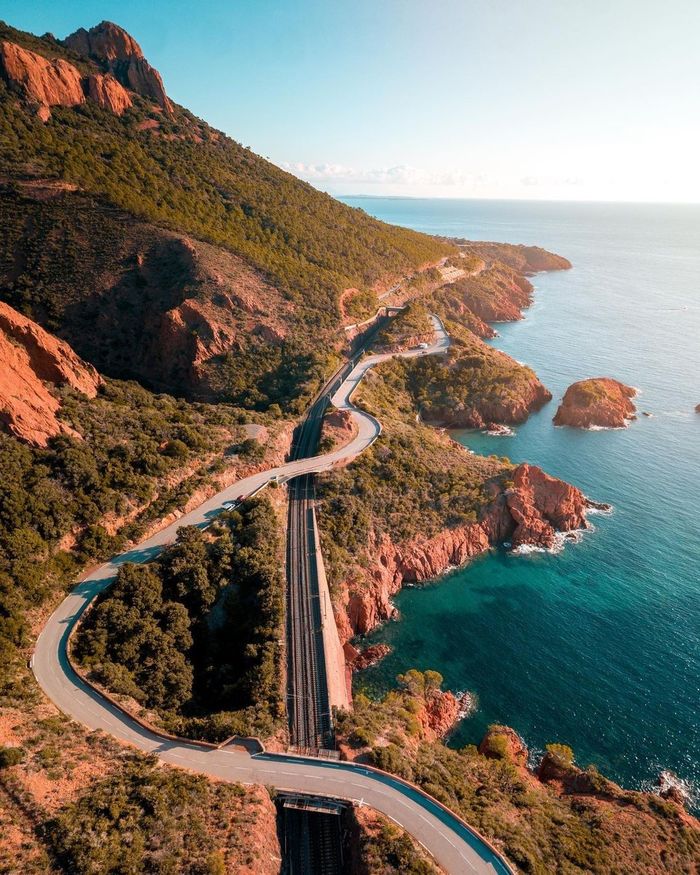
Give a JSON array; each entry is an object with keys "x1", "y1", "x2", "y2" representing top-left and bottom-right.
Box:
[{"x1": 338, "y1": 673, "x2": 700, "y2": 875}]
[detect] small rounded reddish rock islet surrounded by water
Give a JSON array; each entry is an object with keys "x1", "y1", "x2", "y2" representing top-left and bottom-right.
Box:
[{"x1": 554, "y1": 377, "x2": 637, "y2": 428}]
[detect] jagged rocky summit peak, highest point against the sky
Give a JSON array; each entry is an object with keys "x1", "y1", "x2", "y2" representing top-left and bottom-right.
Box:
[{"x1": 63, "y1": 21, "x2": 173, "y2": 115}]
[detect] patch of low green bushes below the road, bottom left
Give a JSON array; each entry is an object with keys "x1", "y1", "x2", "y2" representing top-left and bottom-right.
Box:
[{"x1": 44, "y1": 757, "x2": 269, "y2": 875}]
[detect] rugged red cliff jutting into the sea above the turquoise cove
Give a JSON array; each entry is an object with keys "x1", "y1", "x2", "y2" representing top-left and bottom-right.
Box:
[{"x1": 336, "y1": 464, "x2": 590, "y2": 641}]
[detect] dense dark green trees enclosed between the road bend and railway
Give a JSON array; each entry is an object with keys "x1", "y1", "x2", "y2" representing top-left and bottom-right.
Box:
[{"x1": 74, "y1": 499, "x2": 285, "y2": 741}]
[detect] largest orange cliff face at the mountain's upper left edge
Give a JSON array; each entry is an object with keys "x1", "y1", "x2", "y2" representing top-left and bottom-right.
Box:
[{"x1": 0, "y1": 40, "x2": 85, "y2": 113}]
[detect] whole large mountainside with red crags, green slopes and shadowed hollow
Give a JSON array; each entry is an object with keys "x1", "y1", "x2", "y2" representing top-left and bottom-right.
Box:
[{"x1": 0, "y1": 23, "x2": 454, "y2": 407}]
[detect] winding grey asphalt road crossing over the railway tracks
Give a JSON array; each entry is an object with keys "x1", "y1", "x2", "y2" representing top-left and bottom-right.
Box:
[{"x1": 31, "y1": 316, "x2": 511, "y2": 875}]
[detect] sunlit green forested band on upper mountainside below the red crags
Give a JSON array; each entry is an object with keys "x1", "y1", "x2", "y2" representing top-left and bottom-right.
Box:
[{"x1": 0, "y1": 26, "x2": 454, "y2": 342}]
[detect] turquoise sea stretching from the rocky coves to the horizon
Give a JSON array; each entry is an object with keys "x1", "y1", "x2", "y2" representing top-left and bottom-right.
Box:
[{"x1": 345, "y1": 198, "x2": 700, "y2": 801}]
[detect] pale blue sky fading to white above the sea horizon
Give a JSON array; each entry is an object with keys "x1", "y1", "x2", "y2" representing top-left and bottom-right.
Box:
[{"x1": 5, "y1": 0, "x2": 700, "y2": 203}]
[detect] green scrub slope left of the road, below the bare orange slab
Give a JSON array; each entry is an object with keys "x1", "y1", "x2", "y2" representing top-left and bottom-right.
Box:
[{"x1": 0, "y1": 381, "x2": 278, "y2": 699}]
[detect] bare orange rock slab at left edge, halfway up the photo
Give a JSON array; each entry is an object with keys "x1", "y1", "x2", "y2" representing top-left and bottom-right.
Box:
[{"x1": 0, "y1": 302, "x2": 101, "y2": 446}]
